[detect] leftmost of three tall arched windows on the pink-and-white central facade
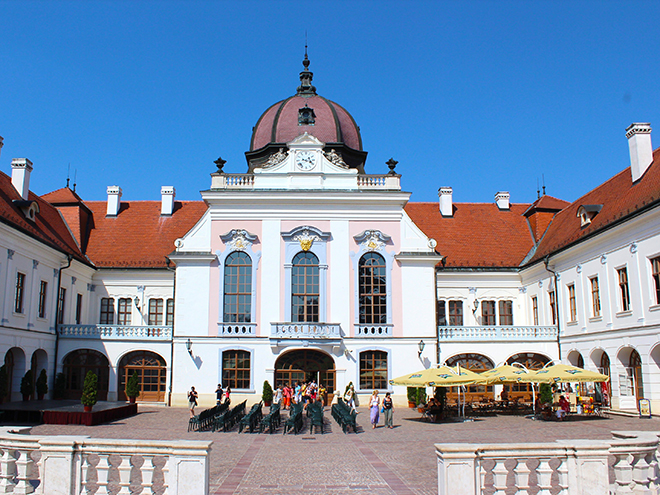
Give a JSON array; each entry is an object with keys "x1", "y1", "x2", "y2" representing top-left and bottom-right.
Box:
[{"x1": 223, "y1": 251, "x2": 252, "y2": 323}]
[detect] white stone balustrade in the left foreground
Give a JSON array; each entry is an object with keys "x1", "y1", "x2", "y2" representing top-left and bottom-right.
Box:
[{"x1": 0, "y1": 427, "x2": 213, "y2": 495}]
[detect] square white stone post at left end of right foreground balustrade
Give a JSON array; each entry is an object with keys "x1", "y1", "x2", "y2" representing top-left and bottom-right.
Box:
[{"x1": 435, "y1": 444, "x2": 481, "y2": 495}]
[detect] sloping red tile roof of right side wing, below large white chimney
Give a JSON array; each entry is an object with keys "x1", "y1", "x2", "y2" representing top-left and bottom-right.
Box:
[{"x1": 530, "y1": 148, "x2": 660, "y2": 263}]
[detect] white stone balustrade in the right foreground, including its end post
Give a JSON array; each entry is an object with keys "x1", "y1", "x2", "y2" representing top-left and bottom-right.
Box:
[{"x1": 435, "y1": 432, "x2": 660, "y2": 495}]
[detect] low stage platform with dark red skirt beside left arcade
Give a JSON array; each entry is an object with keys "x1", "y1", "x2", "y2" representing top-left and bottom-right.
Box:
[{"x1": 0, "y1": 400, "x2": 137, "y2": 426}]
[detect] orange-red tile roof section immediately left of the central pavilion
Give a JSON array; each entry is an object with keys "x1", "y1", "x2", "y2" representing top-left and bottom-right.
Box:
[{"x1": 85, "y1": 201, "x2": 207, "y2": 268}]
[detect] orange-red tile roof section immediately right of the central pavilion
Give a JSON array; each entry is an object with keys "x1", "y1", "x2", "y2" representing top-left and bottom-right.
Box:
[{"x1": 405, "y1": 202, "x2": 534, "y2": 268}]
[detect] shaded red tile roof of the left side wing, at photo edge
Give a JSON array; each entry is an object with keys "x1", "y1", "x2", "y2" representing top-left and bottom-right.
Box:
[{"x1": 0, "y1": 172, "x2": 89, "y2": 264}]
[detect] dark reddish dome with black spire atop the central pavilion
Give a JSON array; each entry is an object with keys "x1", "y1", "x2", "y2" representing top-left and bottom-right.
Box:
[{"x1": 245, "y1": 51, "x2": 366, "y2": 173}]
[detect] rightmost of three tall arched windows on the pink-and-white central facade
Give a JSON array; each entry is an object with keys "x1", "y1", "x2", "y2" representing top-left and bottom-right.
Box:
[{"x1": 359, "y1": 252, "x2": 387, "y2": 323}]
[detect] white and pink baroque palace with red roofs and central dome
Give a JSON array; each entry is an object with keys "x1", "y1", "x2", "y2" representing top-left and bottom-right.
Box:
[{"x1": 0, "y1": 56, "x2": 660, "y2": 411}]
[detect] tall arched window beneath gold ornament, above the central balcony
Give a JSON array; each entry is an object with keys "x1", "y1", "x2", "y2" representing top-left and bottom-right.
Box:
[{"x1": 291, "y1": 251, "x2": 319, "y2": 322}]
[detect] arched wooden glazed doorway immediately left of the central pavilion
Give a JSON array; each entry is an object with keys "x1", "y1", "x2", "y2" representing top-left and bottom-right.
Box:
[{"x1": 117, "y1": 351, "x2": 167, "y2": 402}]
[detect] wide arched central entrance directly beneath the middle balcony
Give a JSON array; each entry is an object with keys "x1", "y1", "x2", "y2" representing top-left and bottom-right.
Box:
[{"x1": 275, "y1": 349, "x2": 336, "y2": 396}]
